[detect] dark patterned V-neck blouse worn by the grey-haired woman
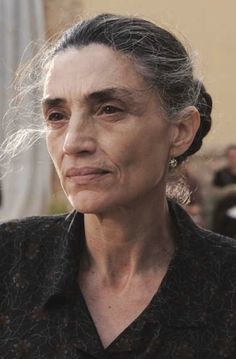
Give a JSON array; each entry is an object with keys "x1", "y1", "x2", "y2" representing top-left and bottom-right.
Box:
[{"x1": 0, "y1": 202, "x2": 236, "y2": 359}]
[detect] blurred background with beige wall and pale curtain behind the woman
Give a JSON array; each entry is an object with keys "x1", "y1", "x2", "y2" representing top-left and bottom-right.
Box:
[{"x1": 0, "y1": 0, "x2": 236, "y2": 238}]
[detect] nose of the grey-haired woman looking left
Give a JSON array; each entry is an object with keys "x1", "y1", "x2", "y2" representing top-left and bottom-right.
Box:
[{"x1": 63, "y1": 115, "x2": 97, "y2": 155}]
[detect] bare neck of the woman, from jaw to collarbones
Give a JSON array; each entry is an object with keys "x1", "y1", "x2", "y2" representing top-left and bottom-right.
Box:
[{"x1": 81, "y1": 194, "x2": 174, "y2": 285}]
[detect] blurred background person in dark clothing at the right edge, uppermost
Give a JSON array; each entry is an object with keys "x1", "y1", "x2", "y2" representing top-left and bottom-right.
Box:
[{"x1": 213, "y1": 144, "x2": 236, "y2": 187}]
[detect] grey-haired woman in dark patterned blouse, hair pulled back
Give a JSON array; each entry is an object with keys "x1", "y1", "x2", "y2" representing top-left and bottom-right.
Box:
[{"x1": 0, "y1": 15, "x2": 236, "y2": 359}]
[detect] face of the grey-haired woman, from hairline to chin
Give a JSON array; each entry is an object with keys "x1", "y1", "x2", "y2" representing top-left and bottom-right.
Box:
[{"x1": 43, "y1": 44, "x2": 175, "y2": 213}]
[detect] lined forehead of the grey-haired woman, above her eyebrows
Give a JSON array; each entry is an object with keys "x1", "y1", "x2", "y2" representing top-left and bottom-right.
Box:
[{"x1": 44, "y1": 44, "x2": 147, "y2": 97}]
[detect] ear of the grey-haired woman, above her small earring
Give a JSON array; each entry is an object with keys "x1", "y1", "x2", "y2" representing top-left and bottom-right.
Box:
[{"x1": 170, "y1": 106, "x2": 200, "y2": 157}]
